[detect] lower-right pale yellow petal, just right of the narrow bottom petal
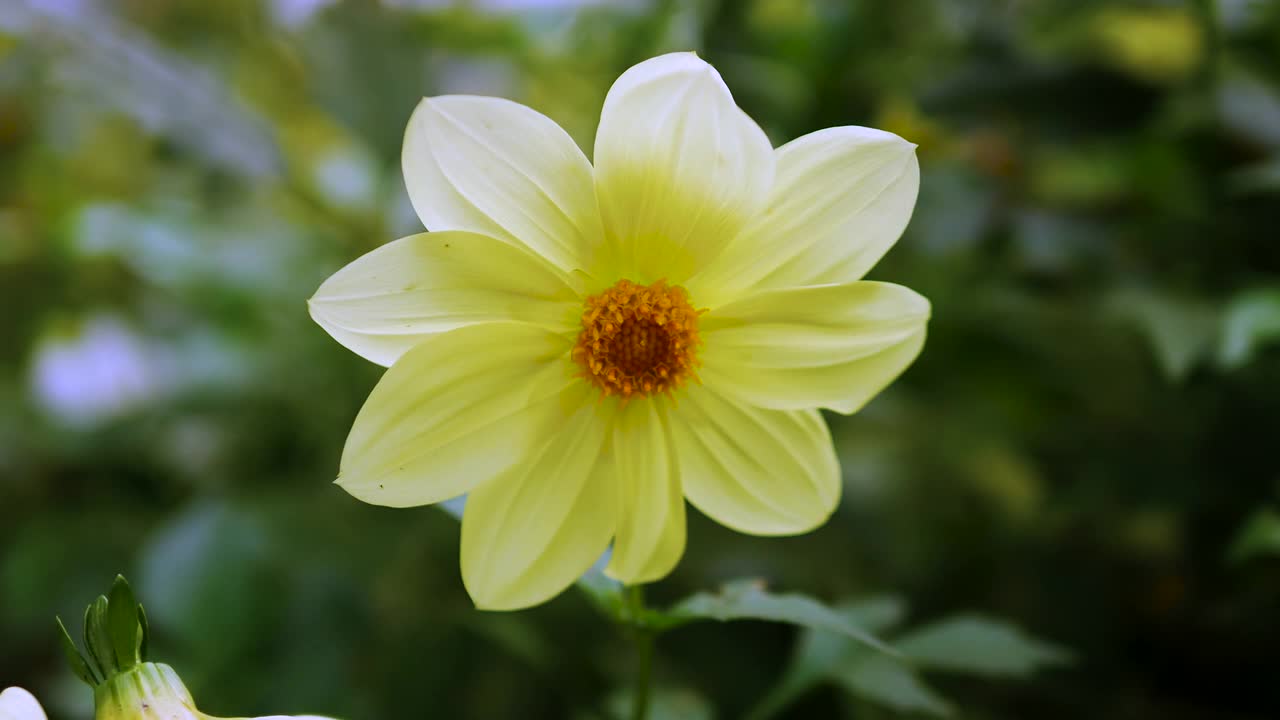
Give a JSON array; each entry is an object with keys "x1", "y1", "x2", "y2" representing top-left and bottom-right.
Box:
[{"x1": 669, "y1": 386, "x2": 841, "y2": 536}]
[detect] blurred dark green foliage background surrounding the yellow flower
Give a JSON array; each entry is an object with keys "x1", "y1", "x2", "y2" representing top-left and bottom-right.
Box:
[{"x1": 0, "y1": 0, "x2": 1280, "y2": 720}]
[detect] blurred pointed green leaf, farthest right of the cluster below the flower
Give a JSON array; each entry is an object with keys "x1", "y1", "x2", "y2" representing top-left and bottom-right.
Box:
[{"x1": 895, "y1": 615, "x2": 1071, "y2": 676}]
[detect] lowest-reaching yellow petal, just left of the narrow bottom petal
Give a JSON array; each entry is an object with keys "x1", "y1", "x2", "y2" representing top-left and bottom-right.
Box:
[{"x1": 462, "y1": 382, "x2": 618, "y2": 610}]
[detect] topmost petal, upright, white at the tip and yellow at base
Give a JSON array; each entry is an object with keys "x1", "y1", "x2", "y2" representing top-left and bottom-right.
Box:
[{"x1": 595, "y1": 53, "x2": 774, "y2": 283}]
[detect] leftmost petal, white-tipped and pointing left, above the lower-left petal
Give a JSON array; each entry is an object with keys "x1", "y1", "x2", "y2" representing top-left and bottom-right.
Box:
[{"x1": 307, "y1": 232, "x2": 577, "y2": 365}]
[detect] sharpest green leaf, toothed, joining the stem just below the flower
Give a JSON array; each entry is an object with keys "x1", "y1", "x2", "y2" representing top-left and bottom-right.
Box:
[{"x1": 654, "y1": 580, "x2": 896, "y2": 655}]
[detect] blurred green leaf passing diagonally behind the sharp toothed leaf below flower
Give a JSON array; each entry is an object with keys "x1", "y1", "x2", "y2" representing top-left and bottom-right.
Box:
[{"x1": 748, "y1": 596, "x2": 906, "y2": 720}]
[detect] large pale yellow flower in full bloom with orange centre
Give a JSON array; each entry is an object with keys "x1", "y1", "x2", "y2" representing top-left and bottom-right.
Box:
[{"x1": 310, "y1": 53, "x2": 929, "y2": 609}]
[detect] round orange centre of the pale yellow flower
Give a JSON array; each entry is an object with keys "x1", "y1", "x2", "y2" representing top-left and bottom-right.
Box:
[{"x1": 573, "y1": 279, "x2": 705, "y2": 400}]
